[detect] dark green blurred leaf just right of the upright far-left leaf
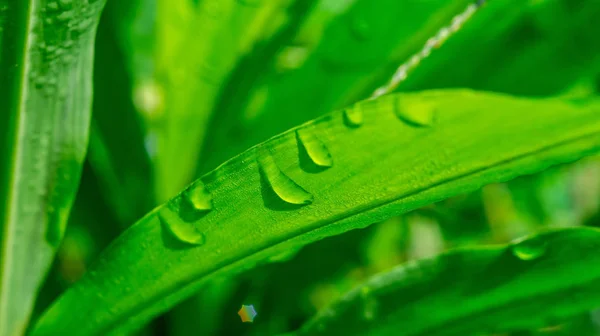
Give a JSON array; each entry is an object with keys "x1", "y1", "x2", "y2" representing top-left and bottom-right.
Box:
[{"x1": 88, "y1": 2, "x2": 154, "y2": 226}]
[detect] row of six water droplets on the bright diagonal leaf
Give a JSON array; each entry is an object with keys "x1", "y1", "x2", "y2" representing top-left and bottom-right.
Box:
[{"x1": 158, "y1": 99, "x2": 435, "y2": 245}]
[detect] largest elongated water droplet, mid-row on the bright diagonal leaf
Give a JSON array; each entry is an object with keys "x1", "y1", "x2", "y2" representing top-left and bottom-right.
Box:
[{"x1": 257, "y1": 151, "x2": 313, "y2": 205}]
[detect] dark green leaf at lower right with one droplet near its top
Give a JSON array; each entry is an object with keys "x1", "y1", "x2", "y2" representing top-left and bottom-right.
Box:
[{"x1": 297, "y1": 228, "x2": 600, "y2": 336}]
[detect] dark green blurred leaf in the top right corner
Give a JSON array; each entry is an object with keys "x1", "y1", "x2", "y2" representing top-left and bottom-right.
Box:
[{"x1": 398, "y1": 0, "x2": 600, "y2": 96}]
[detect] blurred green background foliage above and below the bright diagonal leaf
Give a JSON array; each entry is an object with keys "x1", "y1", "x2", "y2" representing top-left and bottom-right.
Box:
[{"x1": 34, "y1": 0, "x2": 600, "y2": 336}]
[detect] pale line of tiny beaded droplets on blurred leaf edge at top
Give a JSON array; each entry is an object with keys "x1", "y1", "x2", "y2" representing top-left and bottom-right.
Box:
[{"x1": 371, "y1": 0, "x2": 485, "y2": 98}]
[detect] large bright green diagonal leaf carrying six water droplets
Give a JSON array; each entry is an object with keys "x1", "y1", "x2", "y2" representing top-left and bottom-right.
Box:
[{"x1": 34, "y1": 90, "x2": 600, "y2": 335}]
